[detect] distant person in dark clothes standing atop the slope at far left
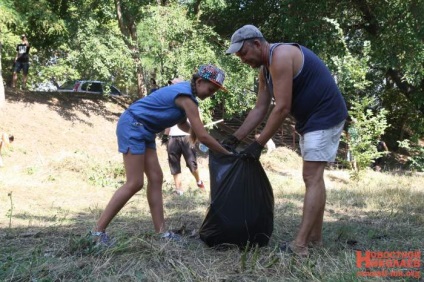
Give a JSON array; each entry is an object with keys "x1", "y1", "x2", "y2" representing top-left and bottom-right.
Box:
[{"x1": 12, "y1": 34, "x2": 30, "y2": 89}]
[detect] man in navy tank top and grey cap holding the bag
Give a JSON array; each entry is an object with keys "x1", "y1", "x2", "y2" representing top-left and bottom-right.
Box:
[{"x1": 222, "y1": 25, "x2": 347, "y2": 257}]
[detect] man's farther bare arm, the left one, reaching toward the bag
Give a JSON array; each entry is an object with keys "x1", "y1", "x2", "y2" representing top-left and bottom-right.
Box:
[{"x1": 233, "y1": 68, "x2": 271, "y2": 144}]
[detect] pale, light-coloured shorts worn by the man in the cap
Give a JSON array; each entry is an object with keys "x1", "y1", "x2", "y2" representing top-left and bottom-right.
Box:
[{"x1": 299, "y1": 121, "x2": 345, "y2": 162}]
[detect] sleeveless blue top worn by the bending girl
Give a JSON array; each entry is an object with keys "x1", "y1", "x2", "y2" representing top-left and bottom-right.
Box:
[{"x1": 127, "y1": 81, "x2": 199, "y2": 133}]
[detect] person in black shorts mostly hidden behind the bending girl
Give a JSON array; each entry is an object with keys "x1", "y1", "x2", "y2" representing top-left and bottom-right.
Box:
[{"x1": 162, "y1": 78, "x2": 205, "y2": 195}]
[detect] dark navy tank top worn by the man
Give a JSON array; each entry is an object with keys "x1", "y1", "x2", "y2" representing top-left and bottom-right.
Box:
[{"x1": 264, "y1": 43, "x2": 347, "y2": 134}]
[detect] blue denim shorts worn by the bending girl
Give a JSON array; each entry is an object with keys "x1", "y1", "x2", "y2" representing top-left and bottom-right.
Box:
[{"x1": 116, "y1": 111, "x2": 156, "y2": 155}]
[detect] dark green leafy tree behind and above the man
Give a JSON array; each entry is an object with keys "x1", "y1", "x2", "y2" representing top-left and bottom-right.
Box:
[{"x1": 196, "y1": 0, "x2": 424, "y2": 145}]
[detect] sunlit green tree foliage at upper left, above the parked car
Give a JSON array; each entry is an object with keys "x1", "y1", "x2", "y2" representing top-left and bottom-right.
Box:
[{"x1": 5, "y1": 0, "x2": 133, "y2": 89}]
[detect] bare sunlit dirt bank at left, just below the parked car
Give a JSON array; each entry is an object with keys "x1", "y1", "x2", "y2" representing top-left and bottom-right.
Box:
[{"x1": 0, "y1": 88, "x2": 130, "y2": 163}]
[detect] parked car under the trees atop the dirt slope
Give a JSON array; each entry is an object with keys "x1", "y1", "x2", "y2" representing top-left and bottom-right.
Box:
[{"x1": 57, "y1": 80, "x2": 122, "y2": 95}]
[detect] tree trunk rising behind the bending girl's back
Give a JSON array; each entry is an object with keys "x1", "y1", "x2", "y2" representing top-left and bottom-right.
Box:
[{"x1": 115, "y1": 0, "x2": 146, "y2": 98}]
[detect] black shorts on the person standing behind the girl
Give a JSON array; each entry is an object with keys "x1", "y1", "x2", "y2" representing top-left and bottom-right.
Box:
[{"x1": 167, "y1": 136, "x2": 197, "y2": 175}]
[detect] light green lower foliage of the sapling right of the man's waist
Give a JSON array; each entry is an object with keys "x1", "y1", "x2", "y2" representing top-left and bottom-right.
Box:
[{"x1": 346, "y1": 97, "x2": 388, "y2": 175}]
